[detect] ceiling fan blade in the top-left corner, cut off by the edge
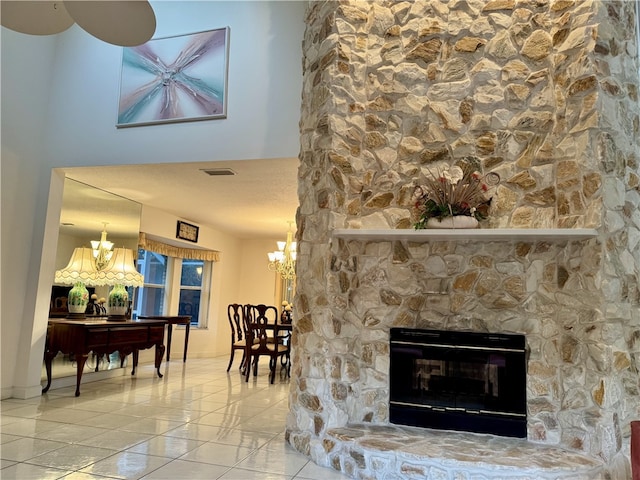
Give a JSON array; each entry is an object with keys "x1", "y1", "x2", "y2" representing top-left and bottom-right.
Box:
[{"x1": 0, "y1": 0, "x2": 73, "y2": 35}]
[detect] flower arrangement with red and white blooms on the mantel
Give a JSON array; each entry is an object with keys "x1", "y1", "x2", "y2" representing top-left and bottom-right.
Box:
[{"x1": 413, "y1": 165, "x2": 500, "y2": 230}]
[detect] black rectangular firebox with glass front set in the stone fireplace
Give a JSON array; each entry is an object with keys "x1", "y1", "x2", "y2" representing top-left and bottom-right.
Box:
[{"x1": 389, "y1": 328, "x2": 527, "y2": 438}]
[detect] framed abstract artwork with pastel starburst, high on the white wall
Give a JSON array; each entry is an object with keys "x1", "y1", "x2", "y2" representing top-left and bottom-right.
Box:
[{"x1": 116, "y1": 27, "x2": 229, "y2": 128}]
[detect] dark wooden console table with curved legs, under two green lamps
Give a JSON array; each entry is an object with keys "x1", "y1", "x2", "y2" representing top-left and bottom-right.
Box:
[{"x1": 42, "y1": 318, "x2": 167, "y2": 397}]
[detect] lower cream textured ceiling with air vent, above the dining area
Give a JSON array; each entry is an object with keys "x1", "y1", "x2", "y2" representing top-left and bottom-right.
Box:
[{"x1": 61, "y1": 158, "x2": 298, "y2": 238}]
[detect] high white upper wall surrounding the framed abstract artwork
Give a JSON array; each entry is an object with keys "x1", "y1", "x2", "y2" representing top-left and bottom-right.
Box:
[{"x1": 46, "y1": 1, "x2": 304, "y2": 170}]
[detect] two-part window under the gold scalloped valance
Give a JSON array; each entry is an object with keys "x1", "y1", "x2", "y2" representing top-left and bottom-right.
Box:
[{"x1": 135, "y1": 249, "x2": 212, "y2": 328}]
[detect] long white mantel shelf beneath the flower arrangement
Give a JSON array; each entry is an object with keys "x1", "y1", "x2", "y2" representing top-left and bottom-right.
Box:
[{"x1": 333, "y1": 228, "x2": 598, "y2": 242}]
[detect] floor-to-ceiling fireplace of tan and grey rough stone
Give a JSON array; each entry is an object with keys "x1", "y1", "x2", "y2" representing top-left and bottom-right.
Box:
[{"x1": 287, "y1": 0, "x2": 640, "y2": 479}]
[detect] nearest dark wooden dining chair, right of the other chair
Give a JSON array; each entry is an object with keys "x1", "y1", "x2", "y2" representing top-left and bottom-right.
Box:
[{"x1": 245, "y1": 304, "x2": 289, "y2": 383}]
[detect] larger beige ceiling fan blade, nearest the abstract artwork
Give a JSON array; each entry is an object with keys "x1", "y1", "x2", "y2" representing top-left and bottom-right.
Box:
[{"x1": 64, "y1": 0, "x2": 156, "y2": 47}]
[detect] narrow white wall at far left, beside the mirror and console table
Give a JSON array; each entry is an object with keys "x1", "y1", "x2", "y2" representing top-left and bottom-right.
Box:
[{"x1": 0, "y1": 28, "x2": 62, "y2": 398}]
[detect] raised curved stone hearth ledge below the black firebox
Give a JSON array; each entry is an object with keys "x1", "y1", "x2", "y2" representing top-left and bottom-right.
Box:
[{"x1": 327, "y1": 424, "x2": 606, "y2": 480}]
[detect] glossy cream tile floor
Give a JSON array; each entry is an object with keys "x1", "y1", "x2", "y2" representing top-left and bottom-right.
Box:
[{"x1": 0, "y1": 357, "x2": 348, "y2": 480}]
